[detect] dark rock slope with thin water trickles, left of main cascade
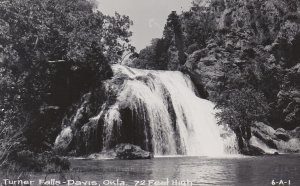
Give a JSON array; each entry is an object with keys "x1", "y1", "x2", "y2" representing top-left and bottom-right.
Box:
[{"x1": 54, "y1": 85, "x2": 113, "y2": 156}]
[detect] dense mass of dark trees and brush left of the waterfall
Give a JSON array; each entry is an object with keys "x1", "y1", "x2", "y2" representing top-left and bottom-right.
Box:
[{"x1": 0, "y1": 0, "x2": 134, "y2": 170}]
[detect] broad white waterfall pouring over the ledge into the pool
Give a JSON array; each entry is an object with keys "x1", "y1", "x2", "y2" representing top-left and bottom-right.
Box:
[{"x1": 98, "y1": 65, "x2": 235, "y2": 156}]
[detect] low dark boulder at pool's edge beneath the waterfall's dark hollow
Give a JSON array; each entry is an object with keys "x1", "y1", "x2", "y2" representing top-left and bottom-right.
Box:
[{"x1": 115, "y1": 144, "x2": 153, "y2": 160}]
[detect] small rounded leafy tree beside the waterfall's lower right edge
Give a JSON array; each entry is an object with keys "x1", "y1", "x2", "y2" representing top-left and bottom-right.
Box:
[{"x1": 216, "y1": 87, "x2": 270, "y2": 148}]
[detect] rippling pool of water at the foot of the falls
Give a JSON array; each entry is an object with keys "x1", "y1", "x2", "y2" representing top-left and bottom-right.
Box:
[{"x1": 0, "y1": 155, "x2": 300, "y2": 186}]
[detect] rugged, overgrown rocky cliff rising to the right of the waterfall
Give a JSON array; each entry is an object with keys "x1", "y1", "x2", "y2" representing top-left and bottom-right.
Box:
[{"x1": 184, "y1": 0, "x2": 300, "y2": 130}]
